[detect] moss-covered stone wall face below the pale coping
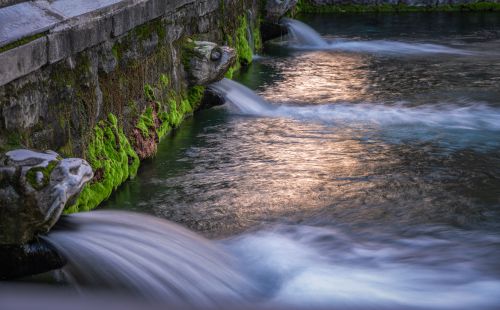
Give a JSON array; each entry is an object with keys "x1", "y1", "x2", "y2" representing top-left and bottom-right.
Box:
[{"x1": 0, "y1": 0, "x2": 261, "y2": 212}]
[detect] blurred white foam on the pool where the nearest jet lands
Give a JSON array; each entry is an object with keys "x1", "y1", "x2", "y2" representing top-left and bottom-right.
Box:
[{"x1": 227, "y1": 226, "x2": 500, "y2": 309}]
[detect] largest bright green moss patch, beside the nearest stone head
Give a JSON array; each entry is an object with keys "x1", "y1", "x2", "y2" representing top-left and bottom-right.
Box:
[{"x1": 66, "y1": 114, "x2": 139, "y2": 213}]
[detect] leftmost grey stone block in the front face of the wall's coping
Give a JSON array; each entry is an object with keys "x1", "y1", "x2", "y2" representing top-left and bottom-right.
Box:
[{"x1": 0, "y1": 37, "x2": 47, "y2": 85}]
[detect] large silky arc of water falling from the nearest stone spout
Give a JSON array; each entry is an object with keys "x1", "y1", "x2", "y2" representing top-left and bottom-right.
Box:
[{"x1": 44, "y1": 211, "x2": 252, "y2": 305}]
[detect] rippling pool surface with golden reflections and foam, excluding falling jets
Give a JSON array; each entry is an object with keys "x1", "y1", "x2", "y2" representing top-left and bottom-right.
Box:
[{"x1": 96, "y1": 13, "x2": 500, "y2": 309}]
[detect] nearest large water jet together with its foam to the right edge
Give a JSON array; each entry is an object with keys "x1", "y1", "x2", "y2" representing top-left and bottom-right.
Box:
[{"x1": 36, "y1": 211, "x2": 500, "y2": 309}]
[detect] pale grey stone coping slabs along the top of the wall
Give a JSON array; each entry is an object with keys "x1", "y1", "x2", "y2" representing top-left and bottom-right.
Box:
[{"x1": 0, "y1": 0, "x2": 197, "y2": 86}]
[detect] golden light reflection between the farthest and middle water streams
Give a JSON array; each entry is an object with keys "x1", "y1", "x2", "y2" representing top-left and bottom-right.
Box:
[{"x1": 261, "y1": 51, "x2": 370, "y2": 104}]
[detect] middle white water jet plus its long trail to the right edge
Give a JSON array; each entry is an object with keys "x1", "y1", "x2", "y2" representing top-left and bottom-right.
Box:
[{"x1": 210, "y1": 79, "x2": 500, "y2": 131}]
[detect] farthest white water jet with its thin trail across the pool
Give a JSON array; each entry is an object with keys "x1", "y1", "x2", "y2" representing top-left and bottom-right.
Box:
[{"x1": 282, "y1": 18, "x2": 473, "y2": 55}]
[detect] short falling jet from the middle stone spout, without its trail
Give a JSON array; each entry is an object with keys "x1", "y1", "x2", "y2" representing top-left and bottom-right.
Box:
[{"x1": 210, "y1": 78, "x2": 273, "y2": 115}]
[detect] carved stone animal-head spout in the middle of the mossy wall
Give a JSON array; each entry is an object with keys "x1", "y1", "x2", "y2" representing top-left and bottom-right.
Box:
[{"x1": 184, "y1": 40, "x2": 236, "y2": 85}]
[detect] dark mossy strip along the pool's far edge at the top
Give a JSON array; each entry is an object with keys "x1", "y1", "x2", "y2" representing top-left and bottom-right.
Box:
[{"x1": 294, "y1": 0, "x2": 500, "y2": 13}]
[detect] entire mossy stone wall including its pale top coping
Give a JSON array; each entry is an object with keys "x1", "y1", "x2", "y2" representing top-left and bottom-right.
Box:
[{"x1": 0, "y1": 0, "x2": 260, "y2": 212}]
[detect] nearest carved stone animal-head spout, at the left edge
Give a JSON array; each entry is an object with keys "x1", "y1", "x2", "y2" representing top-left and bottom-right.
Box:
[{"x1": 0, "y1": 149, "x2": 93, "y2": 244}]
